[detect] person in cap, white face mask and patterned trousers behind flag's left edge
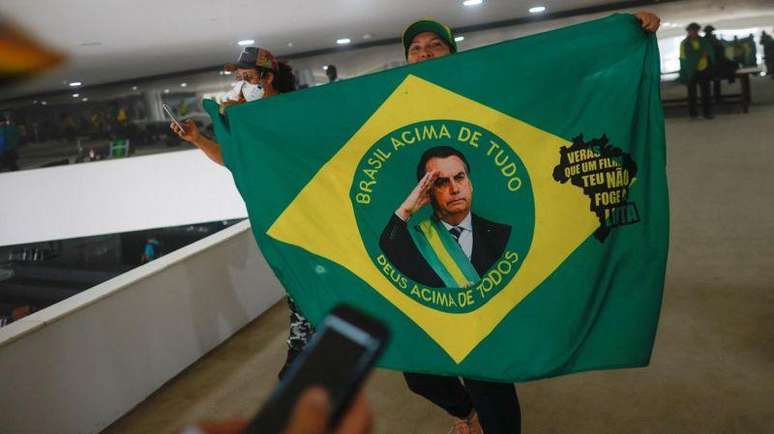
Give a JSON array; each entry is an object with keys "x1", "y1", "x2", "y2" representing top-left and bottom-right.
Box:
[{"x1": 169, "y1": 47, "x2": 314, "y2": 378}]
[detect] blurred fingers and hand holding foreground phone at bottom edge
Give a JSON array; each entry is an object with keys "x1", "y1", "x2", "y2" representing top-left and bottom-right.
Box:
[{"x1": 178, "y1": 387, "x2": 374, "y2": 434}]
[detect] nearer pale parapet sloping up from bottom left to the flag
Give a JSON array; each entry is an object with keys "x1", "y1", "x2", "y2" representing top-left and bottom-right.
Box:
[{"x1": 0, "y1": 221, "x2": 284, "y2": 434}]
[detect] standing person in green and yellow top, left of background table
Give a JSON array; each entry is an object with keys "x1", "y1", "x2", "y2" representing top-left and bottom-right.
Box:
[{"x1": 679, "y1": 23, "x2": 715, "y2": 119}]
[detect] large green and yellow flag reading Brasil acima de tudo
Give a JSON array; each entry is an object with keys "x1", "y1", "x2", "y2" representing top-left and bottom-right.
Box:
[{"x1": 204, "y1": 15, "x2": 668, "y2": 381}]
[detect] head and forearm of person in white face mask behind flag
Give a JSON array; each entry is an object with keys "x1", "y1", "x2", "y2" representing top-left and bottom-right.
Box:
[{"x1": 169, "y1": 47, "x2": 296, "y2": 165}]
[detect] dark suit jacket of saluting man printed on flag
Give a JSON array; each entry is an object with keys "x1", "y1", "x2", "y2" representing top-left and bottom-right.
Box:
[{"x1": 379, "y1": 214, "x2": 511, "y2": 288}]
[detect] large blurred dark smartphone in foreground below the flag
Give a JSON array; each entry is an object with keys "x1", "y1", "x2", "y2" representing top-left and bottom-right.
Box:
[{"x1": 244, "y1": 305, "x2": 389, "y2": 434}]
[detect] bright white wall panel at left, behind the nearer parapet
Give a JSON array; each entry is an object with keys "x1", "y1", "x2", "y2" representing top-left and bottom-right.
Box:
[{"x1": 0, "y1": 150, "x2": 247, "y2": 246}]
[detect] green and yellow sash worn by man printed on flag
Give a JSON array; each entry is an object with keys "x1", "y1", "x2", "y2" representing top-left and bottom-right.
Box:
[{"x1": 409, "y1": 217, "x2": 481, "y2": 288}]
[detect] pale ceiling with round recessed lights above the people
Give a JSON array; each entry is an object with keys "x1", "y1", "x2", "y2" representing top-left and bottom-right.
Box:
[{"x1": 0, "y1": 0, "x2": 774, "y2": 100}]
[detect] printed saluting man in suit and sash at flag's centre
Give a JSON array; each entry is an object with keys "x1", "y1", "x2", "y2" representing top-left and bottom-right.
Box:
[{"x1": 379, "y1": 146, "x2": 511, "y2": 288}]
